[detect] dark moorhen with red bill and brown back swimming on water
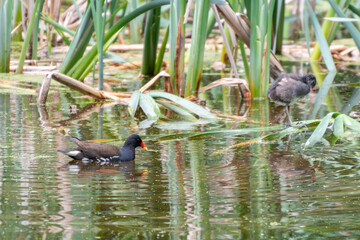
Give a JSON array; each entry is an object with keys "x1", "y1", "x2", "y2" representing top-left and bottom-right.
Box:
[{"x1": 58, "y1": 134, "x2": 147, "y2": 162}]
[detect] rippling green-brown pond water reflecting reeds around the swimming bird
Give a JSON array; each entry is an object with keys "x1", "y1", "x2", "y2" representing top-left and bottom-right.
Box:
[{"x1": 0, "y1": 69, "x2": 360, "y2": 239}]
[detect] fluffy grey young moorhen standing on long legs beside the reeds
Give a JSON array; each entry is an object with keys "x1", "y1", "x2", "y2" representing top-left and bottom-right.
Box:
[{"x1": 268, "y1": 74, "x2": 316, "y2": 126}]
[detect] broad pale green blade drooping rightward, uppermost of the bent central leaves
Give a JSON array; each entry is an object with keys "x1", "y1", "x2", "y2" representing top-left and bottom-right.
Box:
[{"x1": 146, "y1": 92, "x2": 216, "y2": 119}]
